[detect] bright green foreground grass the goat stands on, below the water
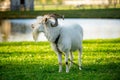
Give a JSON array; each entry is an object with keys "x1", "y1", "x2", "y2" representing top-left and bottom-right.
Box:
[{"x1": 0, "y1": 39, "x2": 120, "y2": 80}]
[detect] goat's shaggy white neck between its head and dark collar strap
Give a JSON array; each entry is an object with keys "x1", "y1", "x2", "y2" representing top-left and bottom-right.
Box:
[{"x1": 44, "y1": 25, "x2": 61, "y2": 42}]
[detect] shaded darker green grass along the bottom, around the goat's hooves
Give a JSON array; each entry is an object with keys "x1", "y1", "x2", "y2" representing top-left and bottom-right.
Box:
[{"x1": 0, "y1": 62, "x2": 120, "y2": 80}]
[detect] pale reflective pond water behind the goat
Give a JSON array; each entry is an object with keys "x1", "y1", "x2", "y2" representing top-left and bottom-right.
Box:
[{"x1": 0, "y1": 19, "x2": 120, "y2": 42}]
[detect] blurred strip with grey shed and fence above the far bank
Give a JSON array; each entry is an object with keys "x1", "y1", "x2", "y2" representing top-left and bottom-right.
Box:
[{"x1": 0, "y1": 0, "x2": 120, "y2": 11}]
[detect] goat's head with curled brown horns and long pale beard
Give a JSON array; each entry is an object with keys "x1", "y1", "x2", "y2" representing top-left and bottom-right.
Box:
[{"x1": 31, "y1": 14, "x2": 64, "y2": 41}]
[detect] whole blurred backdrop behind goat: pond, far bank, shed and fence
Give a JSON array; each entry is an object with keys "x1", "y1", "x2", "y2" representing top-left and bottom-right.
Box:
[{"x1": 0, "y1": 0, "x2": 120, "y2": 42}]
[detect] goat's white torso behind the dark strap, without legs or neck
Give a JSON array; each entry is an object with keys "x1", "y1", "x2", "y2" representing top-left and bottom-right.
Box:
[{"x1": 58, "y1": 24, "x2": 83, "y2": 52}]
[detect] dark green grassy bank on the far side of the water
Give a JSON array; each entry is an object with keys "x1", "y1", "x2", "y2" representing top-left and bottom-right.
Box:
[{"x1": 0, "y1": 8, "x2": 120, "y2": 19}]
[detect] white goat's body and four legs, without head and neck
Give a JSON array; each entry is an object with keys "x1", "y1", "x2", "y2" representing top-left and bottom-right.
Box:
[{"x1": 48, "y1": 24, "x2": 83, "y2": 72}]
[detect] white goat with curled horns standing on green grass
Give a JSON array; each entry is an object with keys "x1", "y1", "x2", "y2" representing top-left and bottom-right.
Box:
[{"x1": 32, "y1": 14, "x2": 83, "y2": 72}]
